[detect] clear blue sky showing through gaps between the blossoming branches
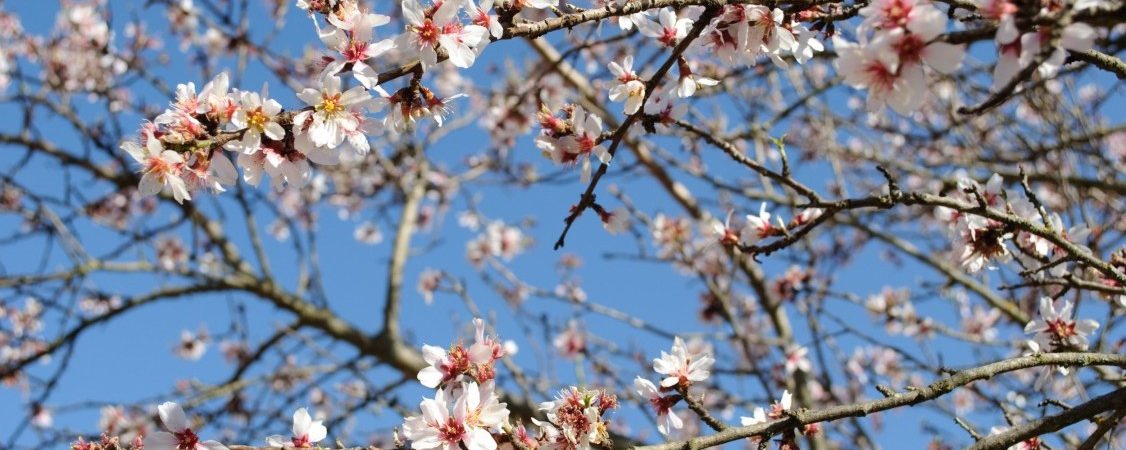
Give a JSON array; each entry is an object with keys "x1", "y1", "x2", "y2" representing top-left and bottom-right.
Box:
[{"x1": 0, "y1": 1, "x2": 1126, "y2": 448}]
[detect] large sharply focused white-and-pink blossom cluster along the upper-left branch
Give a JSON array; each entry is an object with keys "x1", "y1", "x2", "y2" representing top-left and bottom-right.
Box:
[{"x1": 119, "y1": 0, "x2": 572, "y2": 203}]
